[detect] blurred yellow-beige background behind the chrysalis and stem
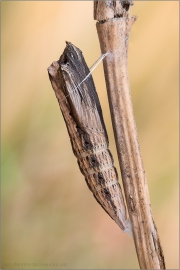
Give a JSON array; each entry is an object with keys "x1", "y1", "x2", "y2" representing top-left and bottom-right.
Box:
[{"x1": 1, "y1": 1, "x2": 179, "y2": 269}]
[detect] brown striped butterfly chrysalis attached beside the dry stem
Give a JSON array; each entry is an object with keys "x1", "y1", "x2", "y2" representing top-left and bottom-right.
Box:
[{"x1": 48, "y1": 42, "x2": 128, "y2": 231}]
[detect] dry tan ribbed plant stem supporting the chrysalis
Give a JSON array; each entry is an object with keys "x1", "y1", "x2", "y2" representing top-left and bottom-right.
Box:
[{"x1": 94, "y1": 1, "x2": 165, "y2": 269}]
